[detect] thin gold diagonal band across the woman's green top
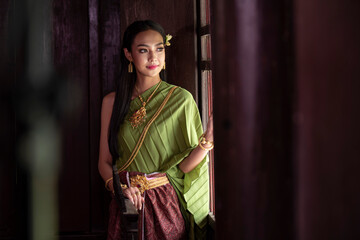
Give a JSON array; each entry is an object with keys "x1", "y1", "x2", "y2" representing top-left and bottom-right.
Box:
[{"x1": 118, "y1": 86, "x2": 177, "y2": 172}]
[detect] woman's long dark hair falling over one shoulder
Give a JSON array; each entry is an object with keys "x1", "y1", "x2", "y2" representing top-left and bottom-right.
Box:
[{"x1": 108, "y1": 20, "x2": 166, "y2": 162}]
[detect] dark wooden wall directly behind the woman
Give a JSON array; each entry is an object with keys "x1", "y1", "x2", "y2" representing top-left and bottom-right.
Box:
[{"x1": 53, "y1": 0, "x2": 196, "y2": 238}]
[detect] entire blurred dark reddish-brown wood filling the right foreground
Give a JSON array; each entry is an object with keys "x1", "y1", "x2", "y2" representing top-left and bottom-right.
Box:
[{"x1": 212, "y1": 0, "x2": 360, "y2": 240}]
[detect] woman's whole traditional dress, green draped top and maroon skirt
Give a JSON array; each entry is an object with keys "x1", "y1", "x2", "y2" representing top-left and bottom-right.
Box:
[{"x1": 108, "y1": 82, "x2": 209, "y2": 239}]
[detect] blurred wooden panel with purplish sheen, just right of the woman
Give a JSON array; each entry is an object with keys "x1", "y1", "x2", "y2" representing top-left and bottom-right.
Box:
[{"x1": 211, "y1": 0, "x2": 294, "y2": 239}]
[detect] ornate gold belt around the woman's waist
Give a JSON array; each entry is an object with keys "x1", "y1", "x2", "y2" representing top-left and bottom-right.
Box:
[{"x1": 130, "y1": 175, "x2": 169, "y2": 194}]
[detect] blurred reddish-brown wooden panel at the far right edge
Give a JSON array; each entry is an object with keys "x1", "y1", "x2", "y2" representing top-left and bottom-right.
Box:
[{"x1": 295, "y1": 0, "x2": 360, "y2": 240}]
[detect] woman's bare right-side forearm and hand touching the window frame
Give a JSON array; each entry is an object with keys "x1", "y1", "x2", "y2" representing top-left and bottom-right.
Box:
[{"x1": 179, "y1": 114, "x2": 214, "y2": 173}]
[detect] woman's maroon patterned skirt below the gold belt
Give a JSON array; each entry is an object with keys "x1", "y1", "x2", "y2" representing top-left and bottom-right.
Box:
[{"x1": 107, "y1": 172, "x2": 187, "y2": 240}]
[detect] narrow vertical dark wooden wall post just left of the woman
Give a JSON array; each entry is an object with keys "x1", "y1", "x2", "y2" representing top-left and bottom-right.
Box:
[{"x1": 88, "y1": 0, "x2": 109, "y2": 233}]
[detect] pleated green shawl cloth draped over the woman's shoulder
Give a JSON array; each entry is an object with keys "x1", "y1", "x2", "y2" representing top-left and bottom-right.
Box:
[{"x1": 117, "y1": 82, "x2": 209, "y2": 236}]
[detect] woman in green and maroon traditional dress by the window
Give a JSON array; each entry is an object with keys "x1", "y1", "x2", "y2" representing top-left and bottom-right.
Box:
[{"x1": 99, "y1": 20, "x2": 213, "y2": 239}]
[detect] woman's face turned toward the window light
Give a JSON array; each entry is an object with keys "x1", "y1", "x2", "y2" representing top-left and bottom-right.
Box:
[{"x1": 124, "y1": 30, "x2": 165, "y2": 77}]
